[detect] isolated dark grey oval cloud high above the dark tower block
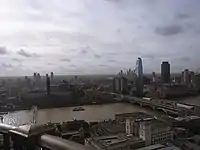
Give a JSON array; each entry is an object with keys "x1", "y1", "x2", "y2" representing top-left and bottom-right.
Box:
[{"x1": 155, "y1": 25, "x2": 183, "y2": 36}]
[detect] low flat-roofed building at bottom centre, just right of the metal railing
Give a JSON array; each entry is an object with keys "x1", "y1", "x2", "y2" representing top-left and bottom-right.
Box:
[{"x1": 85, "y1": 134, "x2": 145, "y2": 150}]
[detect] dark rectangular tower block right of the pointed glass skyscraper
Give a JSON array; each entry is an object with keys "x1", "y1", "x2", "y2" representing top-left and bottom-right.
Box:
[{"x1": 161, "y1": 61, "x2": 170, "y2": 83}]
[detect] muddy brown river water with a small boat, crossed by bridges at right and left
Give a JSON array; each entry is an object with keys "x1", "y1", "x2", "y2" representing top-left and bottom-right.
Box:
[{"x1": 3, "y1": 97, "x2": 200, "y2": 125}]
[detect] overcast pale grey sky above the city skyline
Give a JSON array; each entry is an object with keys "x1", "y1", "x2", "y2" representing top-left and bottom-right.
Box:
[{"x1": 0, "y1": 0, "x2": 200, "y2": 76}]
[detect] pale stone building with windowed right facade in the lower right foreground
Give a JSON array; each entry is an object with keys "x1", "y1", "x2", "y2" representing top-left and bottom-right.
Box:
[{"x1": 139, "y1": 119, "x2": 173, "y2": 146}]
